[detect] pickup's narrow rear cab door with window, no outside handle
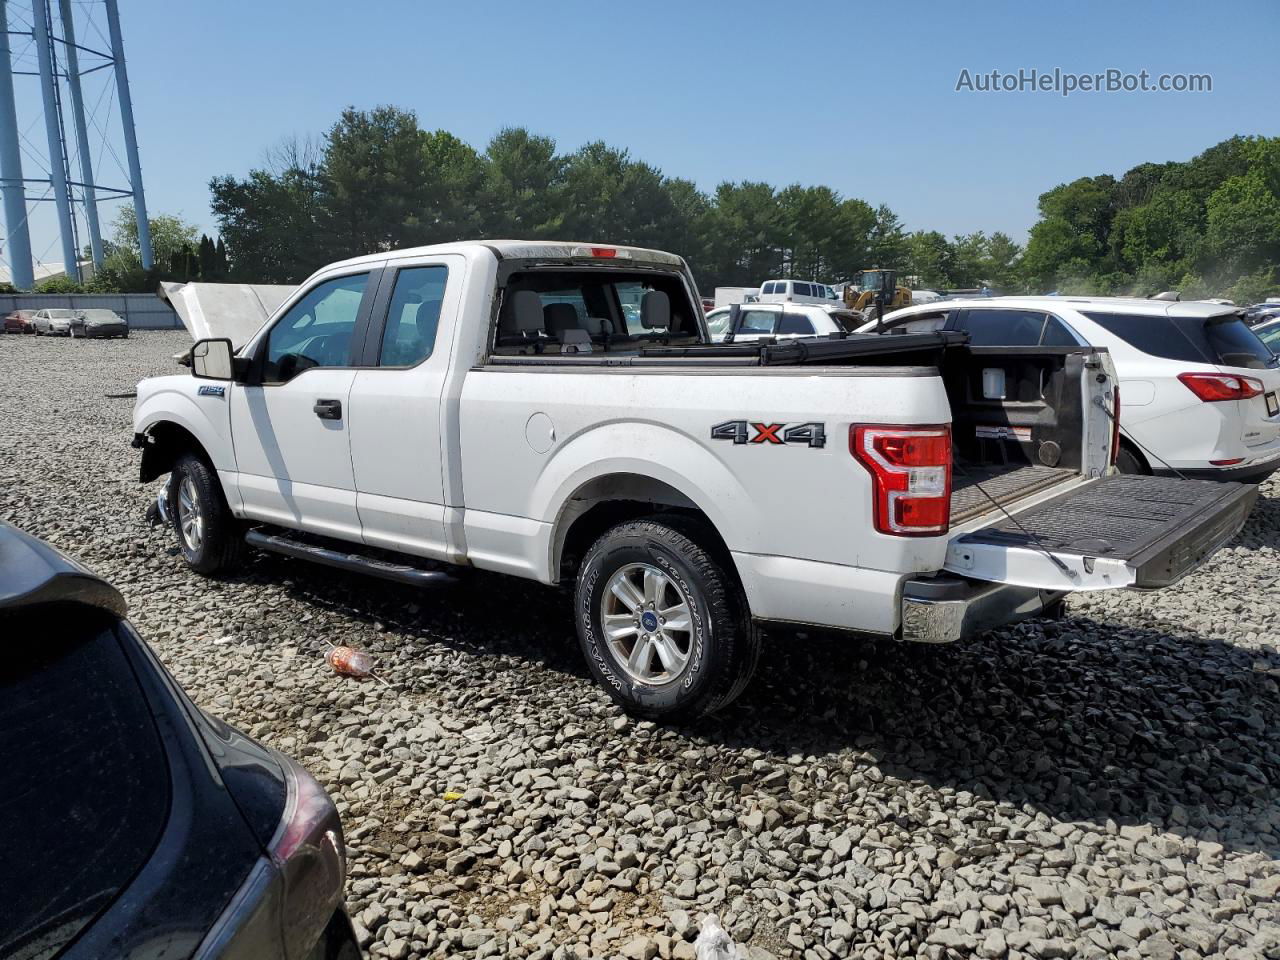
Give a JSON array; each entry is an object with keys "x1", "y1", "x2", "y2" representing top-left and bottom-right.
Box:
[{"x1": 351, "y1": 255, "x2": 466, "y2": 559}]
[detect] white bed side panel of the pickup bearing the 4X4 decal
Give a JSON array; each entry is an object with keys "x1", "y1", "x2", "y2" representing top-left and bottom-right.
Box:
[{"x1": 460, "y1": 366, "x2": 951, "y2": 580}]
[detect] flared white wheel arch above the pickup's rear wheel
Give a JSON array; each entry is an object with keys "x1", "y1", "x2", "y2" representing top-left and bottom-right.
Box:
[{"x1": 530, "y1": 421, "x2": 759, "y2": 550}]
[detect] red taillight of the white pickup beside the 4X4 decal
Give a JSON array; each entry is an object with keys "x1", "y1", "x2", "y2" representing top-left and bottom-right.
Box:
[{"x1": 849, "y1": 424, "x2": 951, "y2": 536}]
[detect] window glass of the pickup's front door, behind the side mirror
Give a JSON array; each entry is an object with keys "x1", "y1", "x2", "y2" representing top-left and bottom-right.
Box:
[{"x1": 262, "y1": 274, "x2": 369, "y2": 383}]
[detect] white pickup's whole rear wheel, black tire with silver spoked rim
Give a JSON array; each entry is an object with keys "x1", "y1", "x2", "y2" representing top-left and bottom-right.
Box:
[{"x1": 573, "y1": 517, "x2": 760, "y2": 719}]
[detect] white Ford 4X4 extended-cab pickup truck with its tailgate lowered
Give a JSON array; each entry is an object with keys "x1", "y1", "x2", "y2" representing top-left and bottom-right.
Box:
[{"x1": 134, "y1": 241, "x2": 1257, "y2": 718}]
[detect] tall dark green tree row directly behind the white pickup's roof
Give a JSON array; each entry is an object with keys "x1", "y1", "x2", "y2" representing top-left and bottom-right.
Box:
[{"x1": 210, "y1": 106, "x2": 1021, "y2": 291}]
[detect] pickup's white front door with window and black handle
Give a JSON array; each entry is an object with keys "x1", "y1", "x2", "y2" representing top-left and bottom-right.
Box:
[{"x1": 230, "y1": 265, "x2": 380, "y2": 541}]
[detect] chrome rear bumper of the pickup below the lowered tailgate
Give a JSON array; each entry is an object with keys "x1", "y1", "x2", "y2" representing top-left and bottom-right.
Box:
[{"x1": 902, "y1": 573, "x2": 1066, "y2": 644}]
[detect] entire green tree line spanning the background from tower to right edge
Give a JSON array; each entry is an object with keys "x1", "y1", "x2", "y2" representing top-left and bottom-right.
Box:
[{"x1": 7, "y1": 106, "x2": 1280, "y2": 303}]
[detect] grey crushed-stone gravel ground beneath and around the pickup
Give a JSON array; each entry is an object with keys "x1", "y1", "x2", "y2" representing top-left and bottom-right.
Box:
[{"x1": 0, "y1": 333, "x2": 1280, "y2": 960}]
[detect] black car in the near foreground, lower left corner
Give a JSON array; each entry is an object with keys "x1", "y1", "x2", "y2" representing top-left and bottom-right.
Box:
[{"x1": 0, "y1": 522, "x2": 360, "y2": 960}]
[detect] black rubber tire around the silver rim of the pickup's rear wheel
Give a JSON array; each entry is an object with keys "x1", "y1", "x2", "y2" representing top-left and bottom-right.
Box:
[{"x1": 573, "y1": 516, "x2": 760, "y2": 721}]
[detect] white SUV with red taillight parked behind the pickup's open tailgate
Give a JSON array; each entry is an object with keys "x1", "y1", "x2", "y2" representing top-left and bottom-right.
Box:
[{"x1": 860, "y1": 297, "x2": 1280, "y2": 483}]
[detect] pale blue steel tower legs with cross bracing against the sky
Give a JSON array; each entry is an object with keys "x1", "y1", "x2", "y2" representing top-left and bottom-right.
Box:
[{"x1": 0, "y1": 0, "x2": 152, "y2": 289}]
